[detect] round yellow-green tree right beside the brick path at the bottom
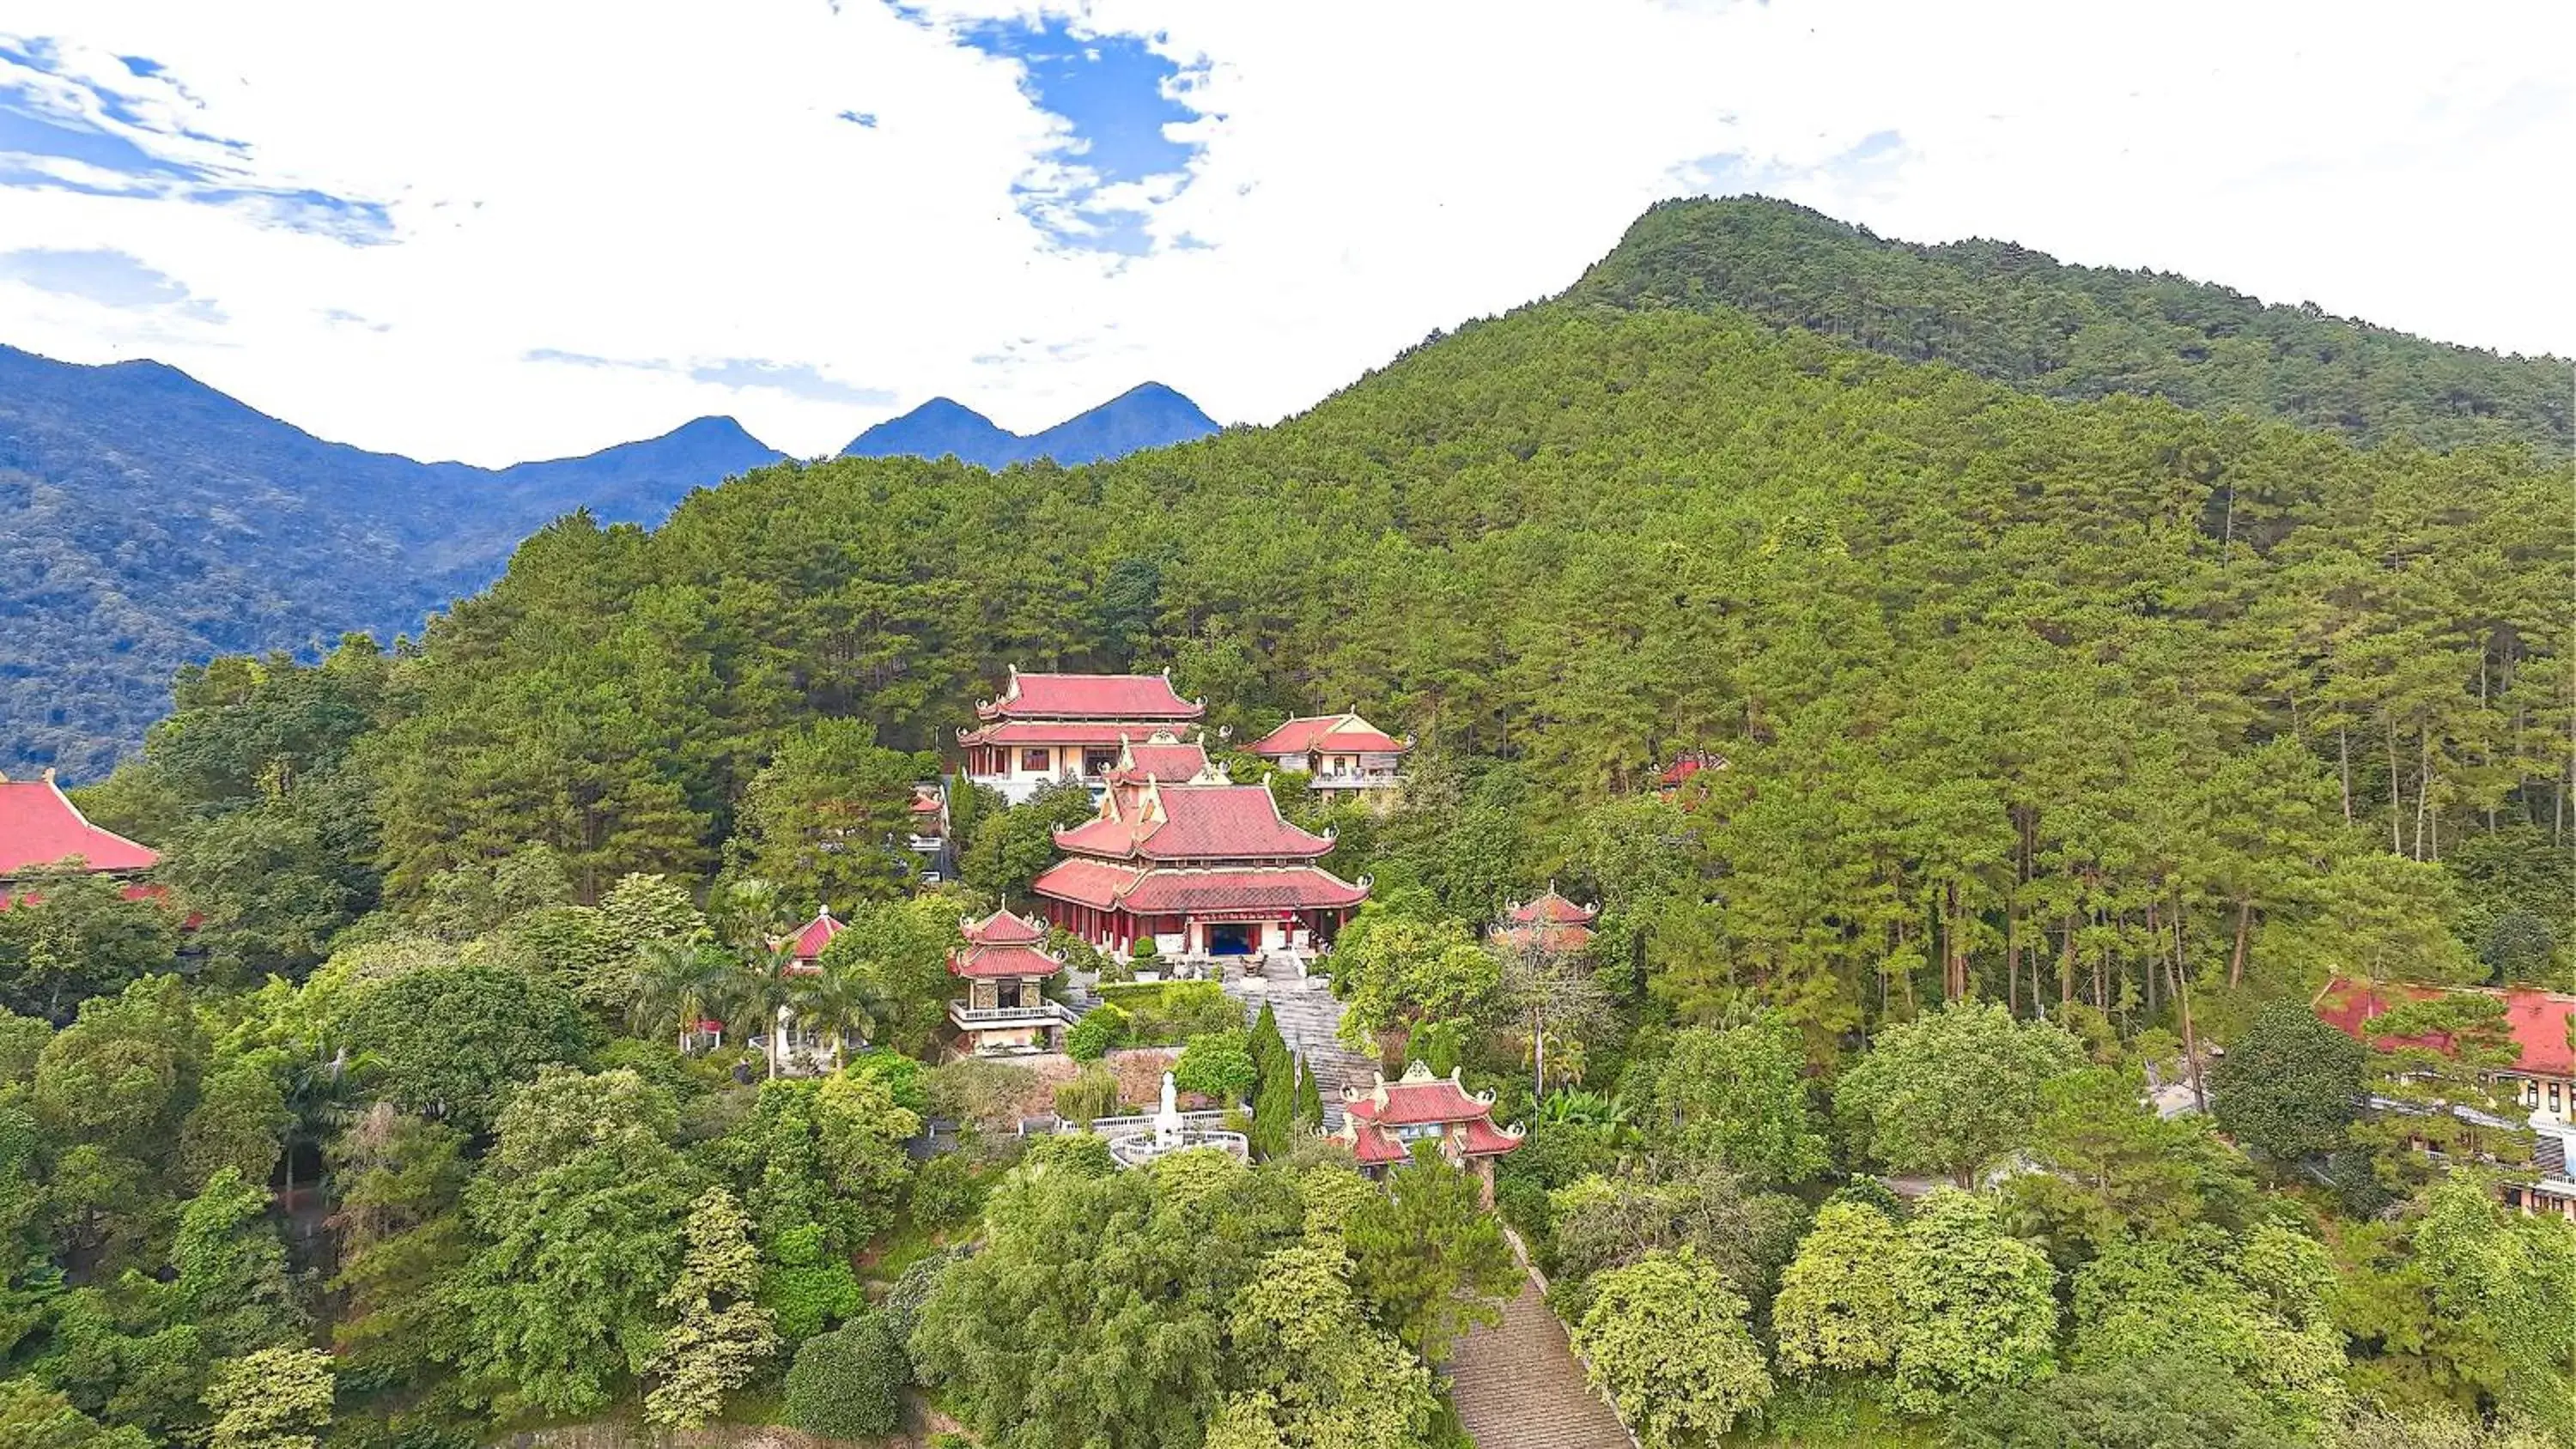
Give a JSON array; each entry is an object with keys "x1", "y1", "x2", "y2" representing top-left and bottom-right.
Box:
[{"x1": 1574, "y1": 1248, "x2": 1772, "y2": 1449}]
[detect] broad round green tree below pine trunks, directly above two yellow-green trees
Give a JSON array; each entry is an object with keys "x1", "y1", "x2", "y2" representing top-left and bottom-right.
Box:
[{"x1": 1834, "y1": 1001, "x2": 2084, "y2": 1186}]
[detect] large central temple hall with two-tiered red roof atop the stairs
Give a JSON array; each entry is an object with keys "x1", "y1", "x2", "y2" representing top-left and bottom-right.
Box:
[{"x1": 1030, "y1": 777, "x2": 1368, "y2": 965}]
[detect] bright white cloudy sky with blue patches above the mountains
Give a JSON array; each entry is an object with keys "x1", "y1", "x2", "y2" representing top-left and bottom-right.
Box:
[{"x1": 0, "y1": 0, "x2": 2576, "y2": 466}]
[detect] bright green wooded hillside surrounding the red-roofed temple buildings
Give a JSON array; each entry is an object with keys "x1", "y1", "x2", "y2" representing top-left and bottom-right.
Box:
[{"x1": 0, "y1": 200, "x2": 2576, "y2": 1449}]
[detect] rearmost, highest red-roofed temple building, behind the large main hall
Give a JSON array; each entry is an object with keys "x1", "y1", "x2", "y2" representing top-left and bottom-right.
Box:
[{"x1": 958, "y1": 670, "x2": 1208, "y2": 805}]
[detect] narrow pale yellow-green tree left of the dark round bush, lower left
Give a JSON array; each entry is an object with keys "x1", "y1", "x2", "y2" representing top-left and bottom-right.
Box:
[{"x1": 644, "y1": 1186, "x2": 778, "y2": 1428}]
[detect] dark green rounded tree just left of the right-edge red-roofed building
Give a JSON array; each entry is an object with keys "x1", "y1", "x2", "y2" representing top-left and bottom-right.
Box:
[{"x1": 2210, "y1": 1001, "x2": 2370, "y2": 1163}]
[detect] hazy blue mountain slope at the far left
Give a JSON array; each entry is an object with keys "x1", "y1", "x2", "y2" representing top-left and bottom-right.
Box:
[{"x1": 0, "y1": 348, "x2": 781, "y2": 777}]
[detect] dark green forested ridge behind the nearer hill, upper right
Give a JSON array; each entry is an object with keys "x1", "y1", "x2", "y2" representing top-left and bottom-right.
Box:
[{"x1": 1566, "y1": 198, "x2": 2576, "y2": 461}]
